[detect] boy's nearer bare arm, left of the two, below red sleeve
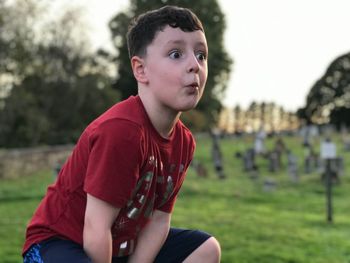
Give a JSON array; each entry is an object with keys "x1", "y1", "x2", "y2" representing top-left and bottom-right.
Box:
[{"x1": 83, "y1": 194, "x2": 120, "y2": 263}]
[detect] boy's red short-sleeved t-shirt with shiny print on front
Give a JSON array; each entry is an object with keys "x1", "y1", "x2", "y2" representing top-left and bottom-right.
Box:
[{"x1": 23, "y1": 96, "x2": 195, "y2": 256}]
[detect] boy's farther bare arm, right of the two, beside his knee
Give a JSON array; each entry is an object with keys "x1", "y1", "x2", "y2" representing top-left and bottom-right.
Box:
[{"x1": 128, "y1": 210, "x2": 171, "y2": 263}]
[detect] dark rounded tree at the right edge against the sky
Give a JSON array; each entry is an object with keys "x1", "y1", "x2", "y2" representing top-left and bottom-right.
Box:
[{"x1": 298, "y1": 53, "x2": 350, "y2": 127}]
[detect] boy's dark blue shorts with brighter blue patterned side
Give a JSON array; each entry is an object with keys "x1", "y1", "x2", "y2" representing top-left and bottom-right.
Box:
[{"x1": 23, "y1": 228, "x2": 211, "y2": 263}]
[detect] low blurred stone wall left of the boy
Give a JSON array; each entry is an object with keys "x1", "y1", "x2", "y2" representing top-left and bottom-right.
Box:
[{"x1": 0, "y1": 145, "x2": 73, "y2": 179}]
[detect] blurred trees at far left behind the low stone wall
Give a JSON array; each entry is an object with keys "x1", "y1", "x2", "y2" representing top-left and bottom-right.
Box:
[{"x1": 0, "y1": 0, "x2": 119, "y2": 147}]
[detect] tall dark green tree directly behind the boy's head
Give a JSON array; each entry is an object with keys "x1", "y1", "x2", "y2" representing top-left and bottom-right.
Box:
[{"x1": 109, "y1": 0, "x2": 232, "y2": 129}]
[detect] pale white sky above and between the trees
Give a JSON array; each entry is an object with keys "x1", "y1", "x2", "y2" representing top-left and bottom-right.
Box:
[{"x1": 49, "y1": 0, "x2": 350, "y2": 111}]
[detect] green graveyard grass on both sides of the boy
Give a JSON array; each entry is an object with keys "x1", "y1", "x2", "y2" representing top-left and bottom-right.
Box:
[{"x1": 0, "y1": 137, "x2": 350, "y2": 263}]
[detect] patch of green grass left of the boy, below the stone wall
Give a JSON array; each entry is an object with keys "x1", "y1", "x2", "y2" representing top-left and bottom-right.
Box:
[{"x1": 0, "y1": 172, "x2": 53, "y2": 263}]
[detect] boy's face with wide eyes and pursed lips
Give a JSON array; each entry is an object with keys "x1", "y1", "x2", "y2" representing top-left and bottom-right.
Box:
[{"x1": 143, "y1": 26, "x2": 208, "y2": 112}]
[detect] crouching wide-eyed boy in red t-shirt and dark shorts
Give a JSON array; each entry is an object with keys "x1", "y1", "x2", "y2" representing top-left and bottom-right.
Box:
[{"x1": 23, "y1": 6, "x2": 220, "y2": 263}]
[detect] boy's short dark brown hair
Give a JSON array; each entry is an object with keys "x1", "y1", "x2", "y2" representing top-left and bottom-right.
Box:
[{"x1": 127, "y1": 5, "x2": 204, "y2": 58}]
